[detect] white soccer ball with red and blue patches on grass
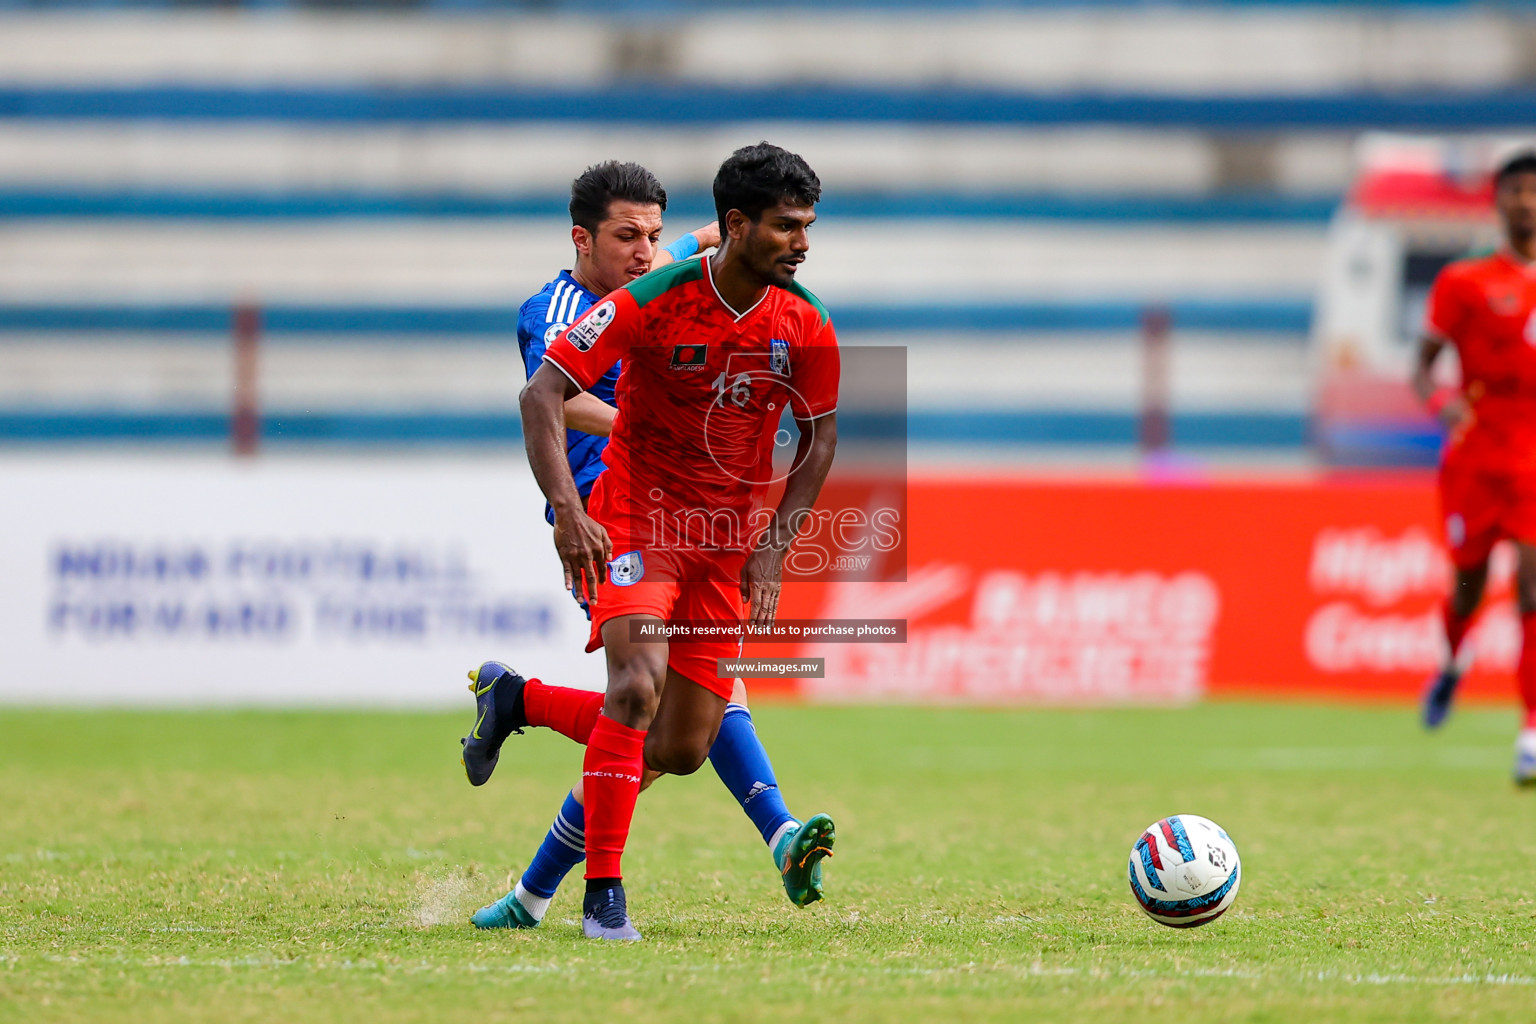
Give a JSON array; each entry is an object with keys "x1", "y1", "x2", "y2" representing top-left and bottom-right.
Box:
[{"x1": 1130, "y1": 814, "x2": 1243, "y2": 927}]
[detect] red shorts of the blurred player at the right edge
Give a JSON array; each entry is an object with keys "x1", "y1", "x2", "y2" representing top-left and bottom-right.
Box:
[{"x1": 1439, "y1": 457, "x2": 1536, "y2": 570}]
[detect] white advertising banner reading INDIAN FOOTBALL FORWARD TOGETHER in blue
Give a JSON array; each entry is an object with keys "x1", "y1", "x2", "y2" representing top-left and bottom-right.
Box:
[{"x1": 0, "y1": 453, "x2": 604, "y2": 708}]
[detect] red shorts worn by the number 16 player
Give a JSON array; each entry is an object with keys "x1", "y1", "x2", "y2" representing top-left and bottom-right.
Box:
[{"x1": 587, "y1": 534, "x2": 745, "y2": 700}]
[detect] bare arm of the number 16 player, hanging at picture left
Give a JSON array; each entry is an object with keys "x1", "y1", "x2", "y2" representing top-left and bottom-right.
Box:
[{"x1": 518, "y1": 362, "x2": 613, "y2": 605}]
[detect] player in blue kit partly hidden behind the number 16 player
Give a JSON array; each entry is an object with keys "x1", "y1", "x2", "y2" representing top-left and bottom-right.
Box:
[{"x1": 464, "y1": 161, "x2": 836, "y2": 938}]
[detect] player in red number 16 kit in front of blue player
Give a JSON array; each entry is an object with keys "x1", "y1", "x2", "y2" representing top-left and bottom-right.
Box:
[{"x1": 519, "y1": 143, "x2": 839, "y2": 938}]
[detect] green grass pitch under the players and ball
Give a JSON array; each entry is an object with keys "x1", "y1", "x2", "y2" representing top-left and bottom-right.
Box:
[{"x1": 0, "y1": 703, "x2": 1536, "y2": 1022}]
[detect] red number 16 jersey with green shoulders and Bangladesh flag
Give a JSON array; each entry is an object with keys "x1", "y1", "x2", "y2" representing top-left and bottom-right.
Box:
[{"x1": 544, "y1": 259, "x2": 839, "y2": 550}]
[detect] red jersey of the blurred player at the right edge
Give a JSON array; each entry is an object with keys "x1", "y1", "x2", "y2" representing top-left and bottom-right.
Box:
[{"x1": 1427, "y1": 252, "x2": 1536, "y2": 473}]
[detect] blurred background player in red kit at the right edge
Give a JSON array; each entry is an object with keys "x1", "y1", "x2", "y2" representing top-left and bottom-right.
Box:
[{"x1": 1413, "y1": 150, "x2": 1536, "y2": 785}]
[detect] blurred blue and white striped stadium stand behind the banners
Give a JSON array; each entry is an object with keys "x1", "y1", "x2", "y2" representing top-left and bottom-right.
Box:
[{"x1": 0, "y1": 0, "x2": 1536, "y2": 453}]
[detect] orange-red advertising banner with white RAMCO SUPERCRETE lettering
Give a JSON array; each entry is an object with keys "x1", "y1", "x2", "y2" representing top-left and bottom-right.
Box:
[{"x1": 763, "y1": 473, "x2": 1521, "y2": 703}]
